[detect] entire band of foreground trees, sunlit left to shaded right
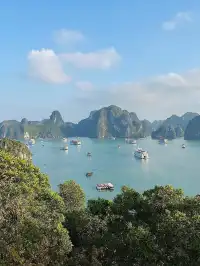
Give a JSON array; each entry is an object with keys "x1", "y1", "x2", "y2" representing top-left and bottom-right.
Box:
[{"x1": 0, "y1": 138, "x2": 200, "y2": 266}]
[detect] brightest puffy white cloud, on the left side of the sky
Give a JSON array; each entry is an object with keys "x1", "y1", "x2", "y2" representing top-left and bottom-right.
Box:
[{"x1": 28, "y1": 49, "x2": 71, "y2": 83}]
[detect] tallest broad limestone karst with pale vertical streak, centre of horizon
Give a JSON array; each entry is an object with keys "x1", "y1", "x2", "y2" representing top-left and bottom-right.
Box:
[{"x1": 76, "y1": 105, "x2": 151, "y2": 138}]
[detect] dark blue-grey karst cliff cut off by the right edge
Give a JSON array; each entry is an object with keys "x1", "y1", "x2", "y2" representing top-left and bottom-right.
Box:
[{"x1": 184, "y1": 116, "x2": 200, "y2": 140}]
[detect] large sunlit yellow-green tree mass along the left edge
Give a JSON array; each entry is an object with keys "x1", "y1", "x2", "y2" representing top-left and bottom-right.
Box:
[{"x1": 0, "y1": 143, "x2": 72, "y2": 266}]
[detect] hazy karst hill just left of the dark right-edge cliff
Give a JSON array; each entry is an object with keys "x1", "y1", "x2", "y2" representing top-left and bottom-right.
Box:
[{"x1": 151, "y1": 112, "x2": 199, "y2": 139}]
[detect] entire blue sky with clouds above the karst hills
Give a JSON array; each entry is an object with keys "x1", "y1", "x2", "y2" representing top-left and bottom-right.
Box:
[{"x1": 0, "y1": 0, "x2": 200, "y2": 122}]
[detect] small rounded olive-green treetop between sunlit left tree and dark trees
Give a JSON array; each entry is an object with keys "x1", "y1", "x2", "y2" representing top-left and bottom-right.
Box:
[{"x1": 59, "y1": 180, "x2": 85, "y2": 212}]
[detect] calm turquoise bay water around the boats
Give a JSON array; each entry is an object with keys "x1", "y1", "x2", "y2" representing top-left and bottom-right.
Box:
[{"x1": 31, "y1": 138, "x2": 200, "y2": 199}]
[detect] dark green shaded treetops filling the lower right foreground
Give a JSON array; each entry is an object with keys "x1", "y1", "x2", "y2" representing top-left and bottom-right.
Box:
[{"x1": 66, "y1": 186, "x2": 200, "y2": 266}]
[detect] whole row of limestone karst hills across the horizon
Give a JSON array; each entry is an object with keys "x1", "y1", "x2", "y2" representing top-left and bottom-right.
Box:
[{"x1": 0, "y1": 105, "x2": 200, "y2": 139}]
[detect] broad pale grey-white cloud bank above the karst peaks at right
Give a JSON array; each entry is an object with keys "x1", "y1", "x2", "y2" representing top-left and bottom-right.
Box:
[{"x1": 74, "y1": 69, "x2": 200, "y2": 120}]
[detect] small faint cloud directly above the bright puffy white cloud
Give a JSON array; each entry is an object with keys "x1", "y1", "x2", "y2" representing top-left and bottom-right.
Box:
[{"x1": 54, "y1": 29, "x2": 85, "y2": 44}]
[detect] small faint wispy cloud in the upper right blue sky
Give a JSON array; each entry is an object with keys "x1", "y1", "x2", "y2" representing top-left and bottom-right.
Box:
[{"x1": 162, "y1": 12, "x2": 192, "y2": 31}]
